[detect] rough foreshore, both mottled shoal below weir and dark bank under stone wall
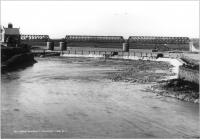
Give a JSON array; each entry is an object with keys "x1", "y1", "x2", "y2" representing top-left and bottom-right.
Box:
[{"x1": 104, "y1": 60, "x2": 199, "y2": 103}]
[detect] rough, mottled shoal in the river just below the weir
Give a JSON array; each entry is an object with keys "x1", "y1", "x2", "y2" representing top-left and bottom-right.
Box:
[{"x1": 108, "y1": 60, "x2": 173, "y2": 83}]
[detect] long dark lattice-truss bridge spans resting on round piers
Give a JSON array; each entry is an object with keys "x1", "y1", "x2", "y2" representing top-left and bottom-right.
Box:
[{"x1": 21, "y1": 34, "x2": 190, "y2": 51}]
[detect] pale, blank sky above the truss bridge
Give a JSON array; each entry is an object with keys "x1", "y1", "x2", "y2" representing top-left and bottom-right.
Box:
[{"x1": 1, "y1": 1, "x2": 199, "y2": 38}]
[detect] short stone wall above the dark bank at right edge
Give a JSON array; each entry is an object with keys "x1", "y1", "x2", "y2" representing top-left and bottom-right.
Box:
[{"x1": 178, "y1": 66, "x2": 199, "y2": 84}]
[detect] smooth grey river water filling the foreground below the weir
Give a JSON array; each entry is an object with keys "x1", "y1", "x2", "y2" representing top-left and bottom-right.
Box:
[{"x1": 1, "y1": 58, "x2": 199, "y2": 138}]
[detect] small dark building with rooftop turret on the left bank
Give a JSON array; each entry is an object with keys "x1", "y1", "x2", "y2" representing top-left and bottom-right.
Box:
[{"x1": 0, "y1": 23, "x2": 20, "y2": 47}]
